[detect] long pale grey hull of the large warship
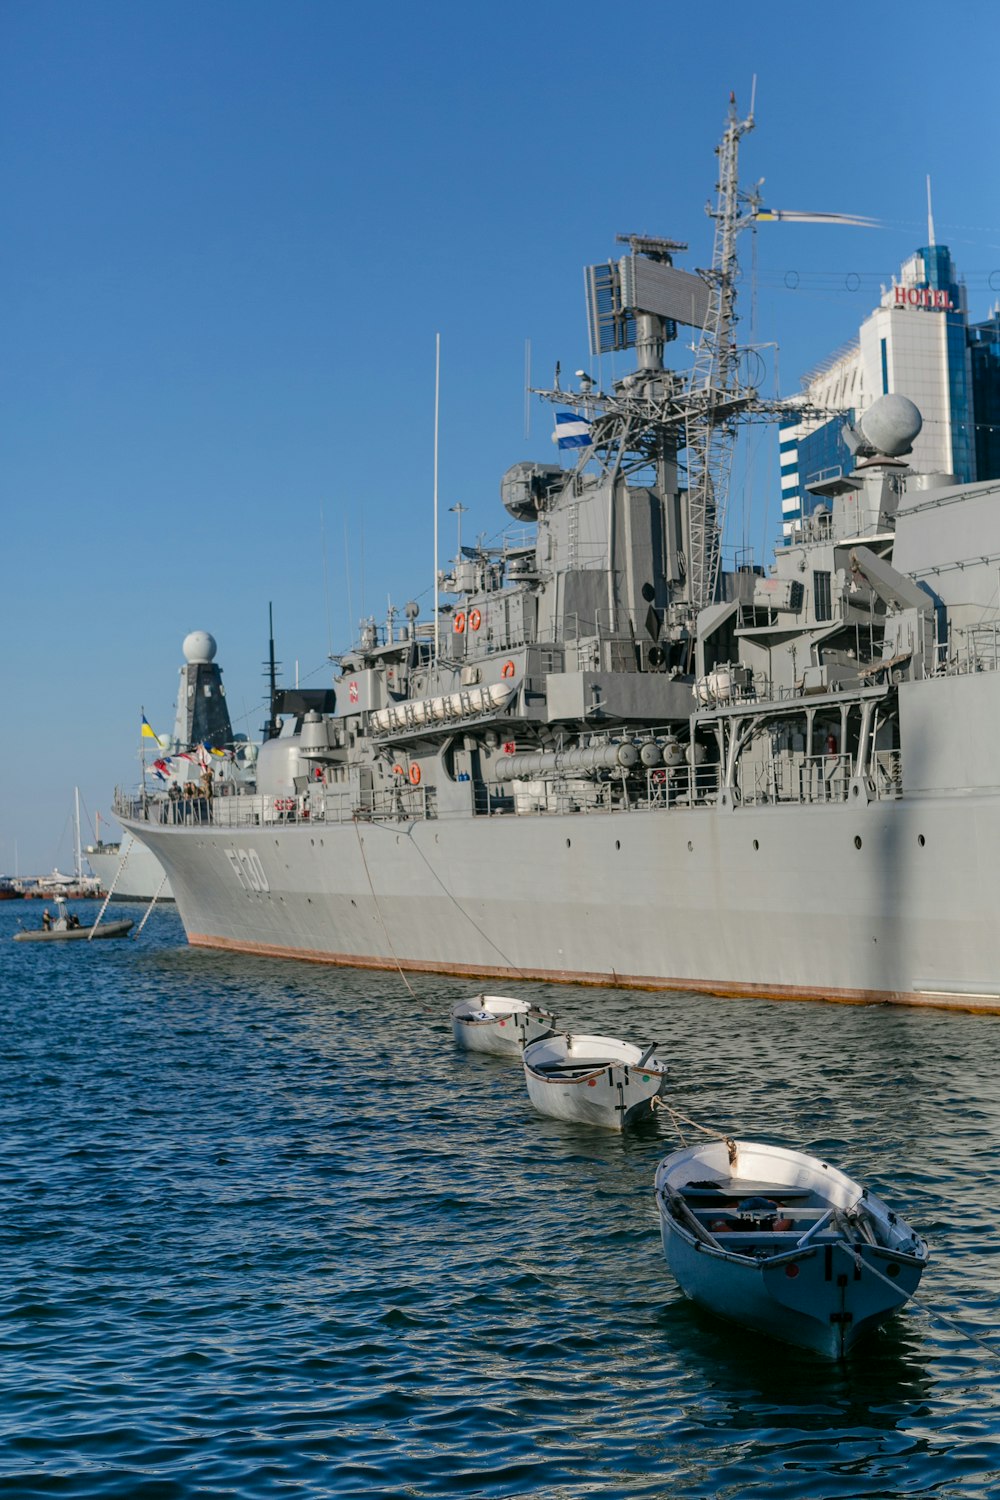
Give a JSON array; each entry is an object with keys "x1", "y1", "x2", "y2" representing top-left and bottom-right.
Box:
[{"x1": 130, "y1": 797, "x2": 1000, "y2": 1013}]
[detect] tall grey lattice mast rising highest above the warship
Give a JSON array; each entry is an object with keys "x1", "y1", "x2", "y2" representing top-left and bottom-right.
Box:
[{"x1": 687, "y1": 95, "x2": 760, "y2": 612}]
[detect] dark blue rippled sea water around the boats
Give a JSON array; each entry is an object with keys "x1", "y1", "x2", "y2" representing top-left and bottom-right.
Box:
[{"x1": 0, "y1": 902, "x2": 1000, "y2": 1500}]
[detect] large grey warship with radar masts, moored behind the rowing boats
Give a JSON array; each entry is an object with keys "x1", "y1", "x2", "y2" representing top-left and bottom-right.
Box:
[{"x1": 118, "y1": 107, "x2": 1000, "y2": 1011}]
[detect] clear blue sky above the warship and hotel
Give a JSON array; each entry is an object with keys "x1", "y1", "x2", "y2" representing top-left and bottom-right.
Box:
[{"x1": 0, "y1": 0, "x2": 1000, "y2": 873}]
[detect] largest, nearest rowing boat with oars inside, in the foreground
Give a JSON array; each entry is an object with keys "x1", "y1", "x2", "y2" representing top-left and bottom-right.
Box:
[{"x1": 655, "y1": 1140, "x2": 930, "y2": 1359}]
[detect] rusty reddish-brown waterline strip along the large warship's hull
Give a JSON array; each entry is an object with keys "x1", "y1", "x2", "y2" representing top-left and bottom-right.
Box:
[{"x1": 187, "y1": 933, "x2": 1000, "y2": 1016}]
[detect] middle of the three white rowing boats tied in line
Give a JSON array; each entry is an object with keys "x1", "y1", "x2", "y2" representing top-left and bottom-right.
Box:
[{"x1": 523, "y1": 1032, "x2": 667, "y2": 1130}]
